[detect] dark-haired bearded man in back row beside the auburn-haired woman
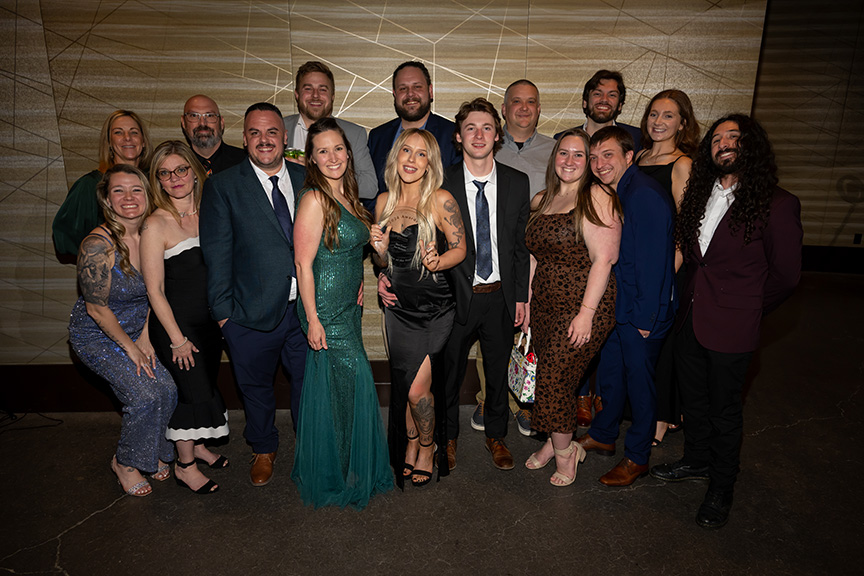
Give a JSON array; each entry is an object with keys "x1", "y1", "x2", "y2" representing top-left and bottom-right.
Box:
[{"x1": 555, "y1": 70, "x2": 642, "y2": 155}]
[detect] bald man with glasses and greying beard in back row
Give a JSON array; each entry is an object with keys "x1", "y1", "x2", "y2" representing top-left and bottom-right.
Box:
[{"x1": 180, "y1": 94, "x2": 246, "y2": 176}]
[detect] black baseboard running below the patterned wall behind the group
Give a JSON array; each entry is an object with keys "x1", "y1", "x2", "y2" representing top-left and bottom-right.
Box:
[{"x1": 0, "y1": 360, "x2": 480, "y2": 413}]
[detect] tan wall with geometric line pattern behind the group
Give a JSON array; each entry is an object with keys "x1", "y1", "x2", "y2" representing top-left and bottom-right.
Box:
[{"x1": 0, "y1": 0, "x2": 768, "y2": 364}]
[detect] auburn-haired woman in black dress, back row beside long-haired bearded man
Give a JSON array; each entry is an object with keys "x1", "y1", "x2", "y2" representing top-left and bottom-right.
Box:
[{"x1": 636, "y1": 90, "x2": 699, "y2": 446}]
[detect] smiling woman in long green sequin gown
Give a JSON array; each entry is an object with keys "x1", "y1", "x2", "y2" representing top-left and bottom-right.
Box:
[{"x1": 291, "y1": 118, "x2": 393, "y2": 509}]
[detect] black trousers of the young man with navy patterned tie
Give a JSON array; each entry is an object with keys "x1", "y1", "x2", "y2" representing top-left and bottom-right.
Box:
[{"x1": 444, "y1": 290, "x2": 514, "y2": 440}]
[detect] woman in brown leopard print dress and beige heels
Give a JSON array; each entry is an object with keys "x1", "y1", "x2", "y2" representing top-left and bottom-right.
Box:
[{"x1": 524, "y1": 129, "x2": 621, "y2": 486}]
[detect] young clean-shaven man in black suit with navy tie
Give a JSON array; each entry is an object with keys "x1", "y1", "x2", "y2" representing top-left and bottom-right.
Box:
[{"x1": 444, "y1": 98, "x2": 530, "y2": 470}]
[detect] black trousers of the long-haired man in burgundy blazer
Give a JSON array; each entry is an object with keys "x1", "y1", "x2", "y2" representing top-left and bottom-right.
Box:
[{"x1": 675, "y1": 312, "x2": 753, "y2": 492}]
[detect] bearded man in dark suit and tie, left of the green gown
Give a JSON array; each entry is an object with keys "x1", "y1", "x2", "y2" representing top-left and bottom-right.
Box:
[{"x1": 200, "y1": 102, "x2": 308, "y2": 486}]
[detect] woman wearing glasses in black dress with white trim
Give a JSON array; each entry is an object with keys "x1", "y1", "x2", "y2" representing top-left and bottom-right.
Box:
[{"x1": 141, "y1": 140, "x2": 228, "y2": 494}]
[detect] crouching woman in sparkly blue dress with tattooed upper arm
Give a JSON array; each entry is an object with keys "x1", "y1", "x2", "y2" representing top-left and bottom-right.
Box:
[{"x1": 69, "y1": 164, "x2": 177, "y2": 496}]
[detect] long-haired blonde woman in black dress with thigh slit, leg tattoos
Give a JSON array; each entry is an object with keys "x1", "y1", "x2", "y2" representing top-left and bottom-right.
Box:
[{"x1": 372, "y1": 129, "x2": 466, "y2": 488}]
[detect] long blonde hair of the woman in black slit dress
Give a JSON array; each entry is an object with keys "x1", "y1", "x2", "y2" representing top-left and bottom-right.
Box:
[{"x1": 379, "y1": 128, "x2": 444, "y2": 278}]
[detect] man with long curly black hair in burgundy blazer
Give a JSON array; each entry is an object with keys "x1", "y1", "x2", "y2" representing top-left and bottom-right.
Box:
[{"x1": 651, "y1": 114, "x2": 803, "y2": 529}]
